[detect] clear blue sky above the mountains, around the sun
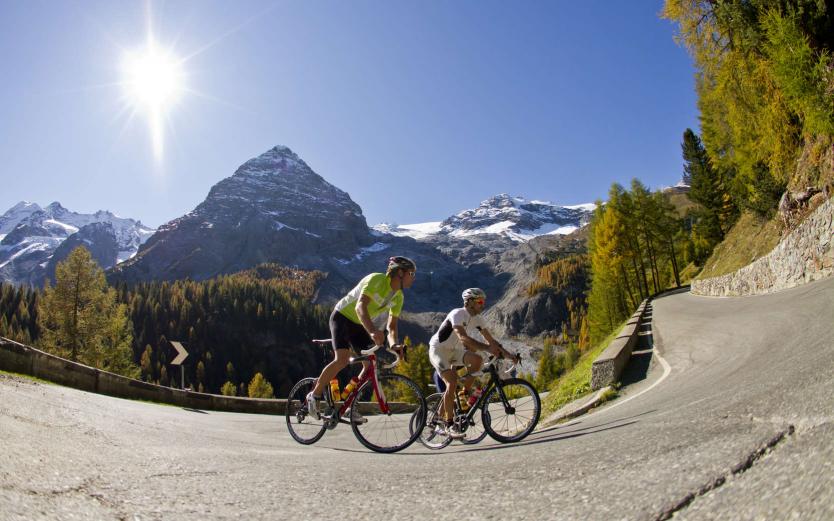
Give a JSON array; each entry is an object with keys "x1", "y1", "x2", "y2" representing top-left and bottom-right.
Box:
[{"x1": 0, "y1": 0, "x2": 698, "y2": 226}]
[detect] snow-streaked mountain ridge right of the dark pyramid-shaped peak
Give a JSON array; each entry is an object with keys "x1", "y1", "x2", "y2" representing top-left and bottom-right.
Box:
[{"x1": 373, "y1": 194, "x2": 595, "y2": 242}]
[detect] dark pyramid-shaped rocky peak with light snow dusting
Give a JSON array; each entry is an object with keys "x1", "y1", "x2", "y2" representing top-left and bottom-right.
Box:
[{"x1": 110, "y1": 147, "x2": 374, "y2": 281}]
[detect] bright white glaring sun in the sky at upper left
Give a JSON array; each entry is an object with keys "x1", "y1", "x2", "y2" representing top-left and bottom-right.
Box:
[{"x1": 121, "y1": 39, "x2": 185, "y2": 159}]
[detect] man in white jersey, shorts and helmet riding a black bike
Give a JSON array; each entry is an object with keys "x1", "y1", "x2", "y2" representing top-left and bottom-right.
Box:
[{"x1": 429, "y1": 288, "x2": 515, "y2": 438}]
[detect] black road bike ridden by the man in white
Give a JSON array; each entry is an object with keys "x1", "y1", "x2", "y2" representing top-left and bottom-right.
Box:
[{"x1": 414, "y1": 356, "x2": 541, "y2": 450}]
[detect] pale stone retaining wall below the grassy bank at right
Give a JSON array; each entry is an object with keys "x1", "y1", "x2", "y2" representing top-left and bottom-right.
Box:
[{"x1": 692, "y1": 195, "x2": 834, "y2": 297}]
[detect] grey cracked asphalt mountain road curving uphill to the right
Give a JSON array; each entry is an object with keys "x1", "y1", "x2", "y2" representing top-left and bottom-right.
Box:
[{"x1": 0, "y1": 278, "x2": 834, "y2": 520}]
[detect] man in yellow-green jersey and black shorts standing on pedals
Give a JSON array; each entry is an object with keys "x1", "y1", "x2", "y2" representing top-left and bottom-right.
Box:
[{"x1": 307, "y1": 257, "x2": 417, "y2": 423}]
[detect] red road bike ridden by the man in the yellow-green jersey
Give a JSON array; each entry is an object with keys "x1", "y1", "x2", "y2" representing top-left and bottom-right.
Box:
[{"x1": 286, "y1": 340, "x2": 426, "y2": 453}]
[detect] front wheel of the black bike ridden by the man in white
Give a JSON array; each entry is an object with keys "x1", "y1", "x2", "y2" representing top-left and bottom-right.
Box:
[{"x1": 481, "y1": 378, "x2": 541, "y2": 443}]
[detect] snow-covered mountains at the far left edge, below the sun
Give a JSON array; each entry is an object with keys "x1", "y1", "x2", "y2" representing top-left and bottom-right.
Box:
[{"x1": 0, "y1": 201, "x2": 154, "y2": 285}]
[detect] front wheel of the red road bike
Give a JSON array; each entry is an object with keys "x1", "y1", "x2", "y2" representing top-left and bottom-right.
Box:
[{"x1": 350, "y1": 374, "x2": 426, "y2": 452}]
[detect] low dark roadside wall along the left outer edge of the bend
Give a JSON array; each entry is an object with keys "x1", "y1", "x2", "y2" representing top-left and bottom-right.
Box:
[{"x1": 0, "y1": 337, "x2": 287, "y2": 414}]
